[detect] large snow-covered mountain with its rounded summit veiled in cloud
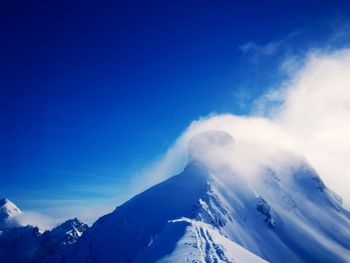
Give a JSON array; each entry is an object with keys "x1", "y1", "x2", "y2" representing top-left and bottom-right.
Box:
[{"x1": 0, "y1": 131, "x2": 350, "y2": 263}]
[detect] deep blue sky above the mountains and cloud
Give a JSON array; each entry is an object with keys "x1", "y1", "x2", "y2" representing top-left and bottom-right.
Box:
[{"x1": 0, "y1": 1, "x2": 350, "y2": 222}]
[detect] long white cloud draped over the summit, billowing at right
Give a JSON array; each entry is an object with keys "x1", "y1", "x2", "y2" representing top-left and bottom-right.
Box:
[{"x1": 133, "y1": 49, "x2": 350, "y2": 206}]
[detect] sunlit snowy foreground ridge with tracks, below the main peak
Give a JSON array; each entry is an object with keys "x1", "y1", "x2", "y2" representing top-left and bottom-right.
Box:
[{"x1": 135, "y1": 218, "x2": 266, "y2": 263}]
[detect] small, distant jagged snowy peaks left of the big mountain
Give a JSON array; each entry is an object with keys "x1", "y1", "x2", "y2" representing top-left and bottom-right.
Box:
[{"x1": 0, "y1": 199, "x2": 88, "y2": 262}]
